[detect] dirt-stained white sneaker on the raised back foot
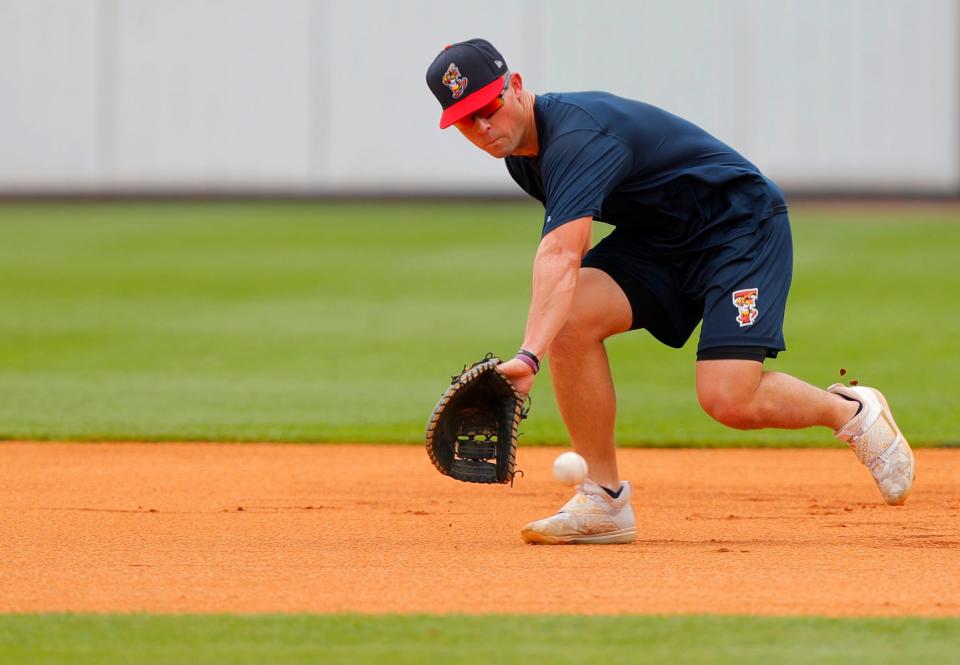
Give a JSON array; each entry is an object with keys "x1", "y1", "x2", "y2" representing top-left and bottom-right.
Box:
[{"x1": 827, "y1": 383, "x2": 916, "y2": 506}]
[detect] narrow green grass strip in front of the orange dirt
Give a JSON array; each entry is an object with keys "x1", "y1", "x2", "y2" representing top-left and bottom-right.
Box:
[{"x1": 0, "y1": 615, "x2": 960, "y2": 665}]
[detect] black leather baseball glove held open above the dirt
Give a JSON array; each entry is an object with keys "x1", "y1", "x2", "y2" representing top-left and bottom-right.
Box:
[{"x1": 427, "y1": 353, "x2": 528, "y2": 483}]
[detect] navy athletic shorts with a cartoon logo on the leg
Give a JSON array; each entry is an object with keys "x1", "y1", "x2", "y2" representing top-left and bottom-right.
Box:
[{"x1": 581, "y1": 213, "x2": 793, "y2": 360}]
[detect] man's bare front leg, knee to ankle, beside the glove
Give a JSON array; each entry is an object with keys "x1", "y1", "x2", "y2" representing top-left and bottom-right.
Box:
[{"x1": 549, "y1": 268, "x2": 633, "y2": 490}]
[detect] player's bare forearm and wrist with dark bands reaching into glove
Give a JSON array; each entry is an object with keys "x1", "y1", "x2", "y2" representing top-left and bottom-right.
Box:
[{"x1": 498, "y1": 217, "x2": 593, "y2": 394}]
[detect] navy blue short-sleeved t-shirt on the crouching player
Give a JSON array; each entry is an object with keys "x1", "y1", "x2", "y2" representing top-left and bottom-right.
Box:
[{"x1": 506, "y1": 92, "x2": 786, "y2": 253}]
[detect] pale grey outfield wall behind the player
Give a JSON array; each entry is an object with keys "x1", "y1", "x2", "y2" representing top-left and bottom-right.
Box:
[{"x1": 0, "y1": 0, "x2": 960, "y2": 195}]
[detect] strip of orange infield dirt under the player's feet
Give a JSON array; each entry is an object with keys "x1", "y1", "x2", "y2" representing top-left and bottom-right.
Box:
[{"x1": 0, "y1": 443, "x2": 960, "y2": 616}]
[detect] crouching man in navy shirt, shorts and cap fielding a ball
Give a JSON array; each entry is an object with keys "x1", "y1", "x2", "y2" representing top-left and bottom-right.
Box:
[{"x1": 427, "y1": 39, "x2": 915, "y2": 543}]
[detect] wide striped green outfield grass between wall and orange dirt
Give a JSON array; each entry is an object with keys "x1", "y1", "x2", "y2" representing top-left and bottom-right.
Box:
[{"x1": 0, "y1": 202, "x2": 960, "y2": 446}]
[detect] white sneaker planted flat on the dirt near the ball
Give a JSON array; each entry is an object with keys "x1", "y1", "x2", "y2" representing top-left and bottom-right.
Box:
[{"x1": 520, "y1": 478, "x2": 637, "y2": 545}]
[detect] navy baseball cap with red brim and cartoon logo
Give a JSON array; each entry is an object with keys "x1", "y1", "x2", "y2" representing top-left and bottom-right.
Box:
[{"x1": 427, "y1": 39, "x2": 507, "y2": 129}]
